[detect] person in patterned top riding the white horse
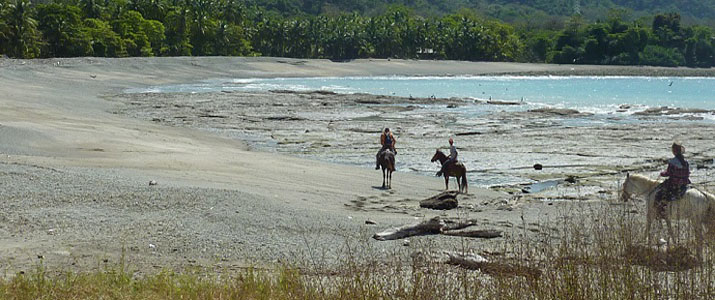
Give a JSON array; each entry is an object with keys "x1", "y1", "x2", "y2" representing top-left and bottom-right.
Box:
[{"x1": 655, "y1": 142, "x2": 690, "y2": 213}]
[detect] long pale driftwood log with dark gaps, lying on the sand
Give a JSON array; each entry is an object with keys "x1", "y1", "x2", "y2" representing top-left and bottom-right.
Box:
[{"x1": 372, "y1": 217, "x2": 501, "y2": 241}]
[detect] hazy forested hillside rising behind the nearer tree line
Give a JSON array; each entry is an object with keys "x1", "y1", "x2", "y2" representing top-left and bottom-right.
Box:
[{"x1": 246, "y1": 0, "x2": 715, "y2": 25}]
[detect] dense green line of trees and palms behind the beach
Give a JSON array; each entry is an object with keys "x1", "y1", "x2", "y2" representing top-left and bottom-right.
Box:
[{"x1": 0, "y1": 0, "x2": 715, "y2": 67}]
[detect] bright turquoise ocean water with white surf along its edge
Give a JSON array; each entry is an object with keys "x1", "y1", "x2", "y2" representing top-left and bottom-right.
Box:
[{"x1": 129, "y1": 76, "x2": 715, "y2": 120}]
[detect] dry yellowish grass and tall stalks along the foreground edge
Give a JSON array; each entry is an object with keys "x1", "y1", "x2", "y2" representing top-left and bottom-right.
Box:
[{"x1": 0, "y1": 200, "x2": 715, "y2": 299}]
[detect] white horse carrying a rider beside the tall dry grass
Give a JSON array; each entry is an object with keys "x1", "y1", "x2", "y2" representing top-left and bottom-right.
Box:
[{"x1": 621, "y1": 174, "x2": 715, "y2": 256}]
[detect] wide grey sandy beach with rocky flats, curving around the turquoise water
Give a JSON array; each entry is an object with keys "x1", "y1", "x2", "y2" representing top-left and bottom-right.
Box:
[{"x1": 0, "y1": 57, "x2": 715, "y2": 276}]
